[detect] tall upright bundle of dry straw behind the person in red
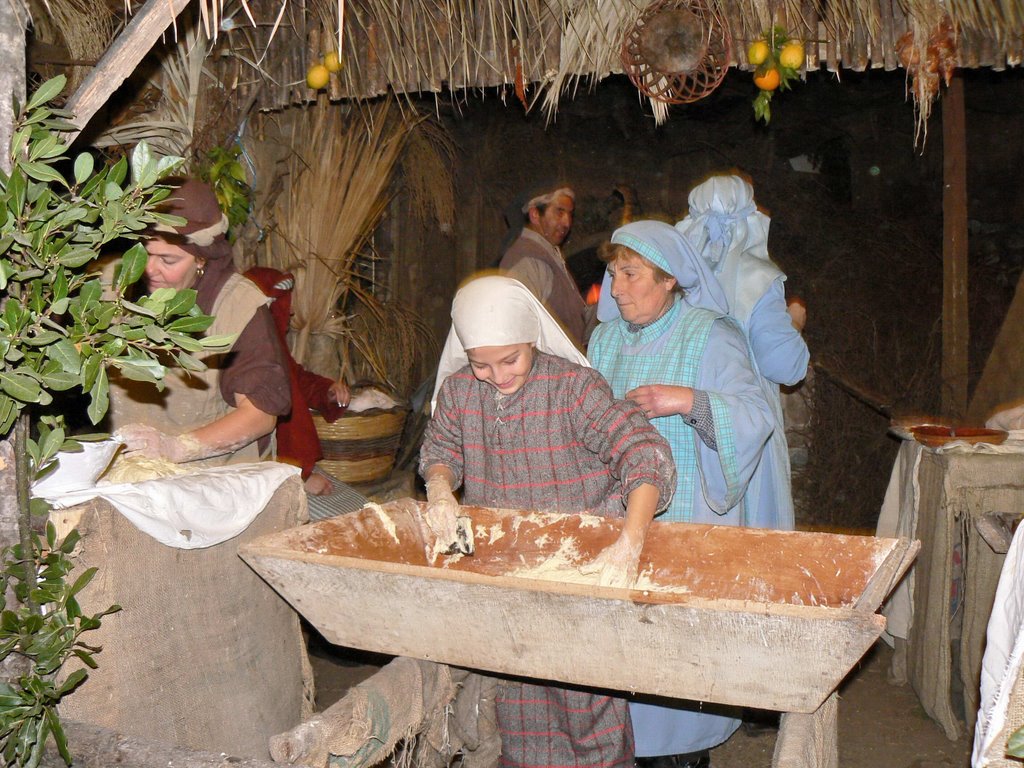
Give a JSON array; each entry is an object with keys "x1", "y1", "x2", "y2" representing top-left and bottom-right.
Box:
[{"x1": 266, "y1": 98, "x2": 414, "y2": 375}]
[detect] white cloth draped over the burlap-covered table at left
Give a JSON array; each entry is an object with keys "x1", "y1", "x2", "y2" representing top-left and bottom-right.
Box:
[{"x1": 37, "y1": 462, "x2": 300, "y2": 549}]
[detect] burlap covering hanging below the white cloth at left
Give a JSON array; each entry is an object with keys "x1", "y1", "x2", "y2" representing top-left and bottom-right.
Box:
[{"x1": 51, "y1": 476, "x2": 311, "y2": 759}]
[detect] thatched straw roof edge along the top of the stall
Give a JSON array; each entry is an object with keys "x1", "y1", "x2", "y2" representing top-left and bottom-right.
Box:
[{"x1": 209, "y1": 0, "x2": 1024, "y2": 113}]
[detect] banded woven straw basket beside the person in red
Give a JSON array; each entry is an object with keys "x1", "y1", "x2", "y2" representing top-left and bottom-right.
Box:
[{"x1": 313, "y1": 408, "x2": 409, "y2": 482}]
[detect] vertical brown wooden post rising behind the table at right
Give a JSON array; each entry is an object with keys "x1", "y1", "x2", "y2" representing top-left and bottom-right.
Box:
[{"x1": 942, "y1": 75, "x2": 970, "y2": 418}]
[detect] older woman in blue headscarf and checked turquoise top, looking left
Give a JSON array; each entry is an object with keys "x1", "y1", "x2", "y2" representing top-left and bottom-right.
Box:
[{"x1": 588, "y1": 221, "x2": 772, "y2": 768}]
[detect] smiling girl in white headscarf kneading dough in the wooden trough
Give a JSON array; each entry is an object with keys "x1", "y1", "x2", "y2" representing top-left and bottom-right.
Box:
[{"x1": 420, "y1": 276, "x2": 675, "y2": 768}]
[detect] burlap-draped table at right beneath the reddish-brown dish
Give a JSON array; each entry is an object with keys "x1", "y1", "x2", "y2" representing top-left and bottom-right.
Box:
[{"x1": 878, "y1": 439, "x2": 1024, "y2": 739}]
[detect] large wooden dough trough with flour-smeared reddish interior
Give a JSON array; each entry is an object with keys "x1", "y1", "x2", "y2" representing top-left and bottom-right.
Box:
[{"x1": 241, "y1": 499, "x2": 919, "y2": 713}]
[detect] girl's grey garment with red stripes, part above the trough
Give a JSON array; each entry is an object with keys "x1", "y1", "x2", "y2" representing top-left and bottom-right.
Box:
[{"x1": 420, "y1": 351, "x2": 676, "y2": 517}]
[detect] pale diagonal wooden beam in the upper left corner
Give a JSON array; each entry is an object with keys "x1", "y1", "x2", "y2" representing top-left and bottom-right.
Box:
[{"x1": 66, "y1": 0, "x2": 188, "y2": 143}]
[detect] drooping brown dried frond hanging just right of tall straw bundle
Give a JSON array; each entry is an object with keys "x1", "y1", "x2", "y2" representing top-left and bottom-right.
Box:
[{"x1": 401, "y1": 119, "x2": 456, "y2": 231}]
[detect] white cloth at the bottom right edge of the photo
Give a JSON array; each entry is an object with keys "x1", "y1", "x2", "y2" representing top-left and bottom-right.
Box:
[{"x1": 971, "y1": 525, "x2": 1024, "y2": 768}]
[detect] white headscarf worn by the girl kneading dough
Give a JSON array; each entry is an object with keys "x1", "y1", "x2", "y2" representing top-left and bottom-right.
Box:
[{"x1": 430, "y1": 274, "x2": 590, "y2": 413}]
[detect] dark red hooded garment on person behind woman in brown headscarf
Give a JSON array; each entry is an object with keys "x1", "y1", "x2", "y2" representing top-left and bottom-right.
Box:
[{"x1": 246, "y1": 266, "x2": 345, "y2": 479}]
